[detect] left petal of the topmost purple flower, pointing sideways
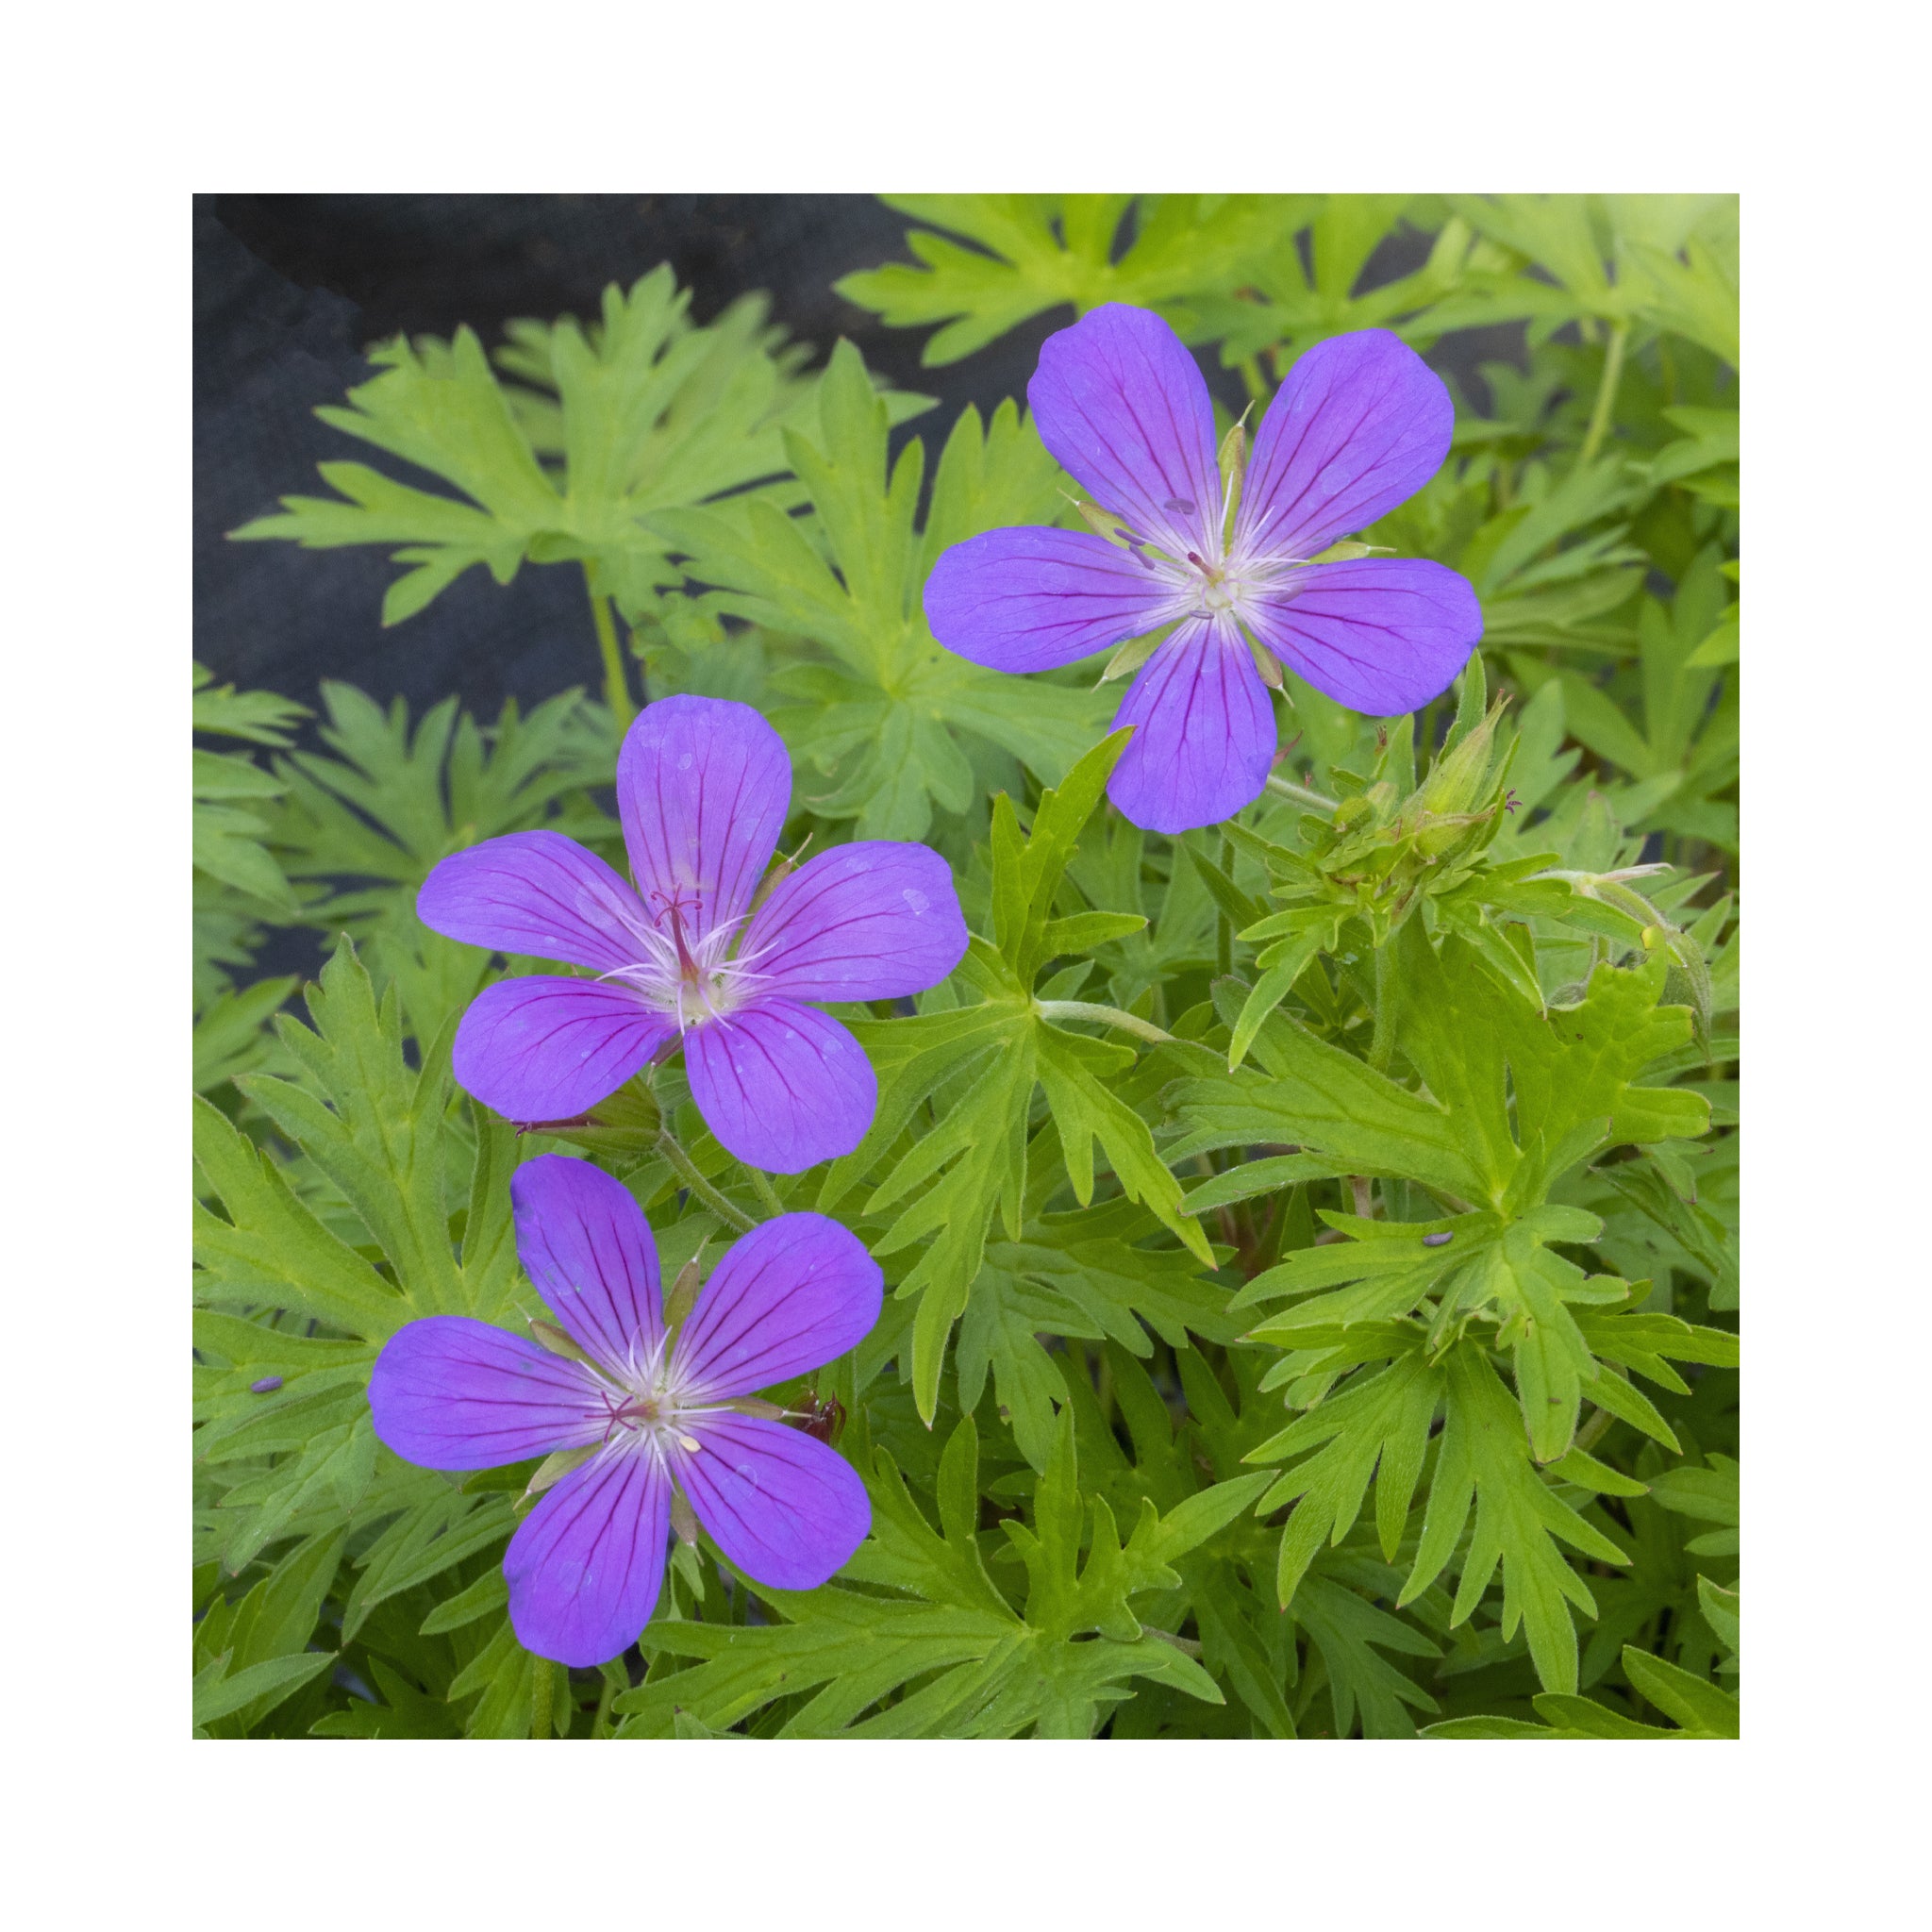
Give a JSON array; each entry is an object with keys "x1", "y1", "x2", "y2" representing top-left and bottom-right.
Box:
[{"x1": 925, "y1": 525, "x2": 1176, "y2": 671}]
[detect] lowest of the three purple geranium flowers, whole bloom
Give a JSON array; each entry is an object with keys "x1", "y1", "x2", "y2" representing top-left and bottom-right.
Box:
[{"x1": 369, "y1": 1154, "x2": 883, "y2": 1667}]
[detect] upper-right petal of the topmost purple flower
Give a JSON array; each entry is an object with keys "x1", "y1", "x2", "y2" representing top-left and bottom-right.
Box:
[{"x1": 1235, "y1": 328, "x2": 1455, "y2": 557}]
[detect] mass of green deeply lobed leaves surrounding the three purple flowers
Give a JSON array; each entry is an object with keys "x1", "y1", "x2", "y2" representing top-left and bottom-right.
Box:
[{"x1": 195, "y1": 195, "x2": 1739, "y2": 1737}]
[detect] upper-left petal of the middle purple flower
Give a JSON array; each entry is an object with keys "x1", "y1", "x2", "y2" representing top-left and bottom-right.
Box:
[{"x1": 415, "y1": 833, "x2": 643, "y2": 972}]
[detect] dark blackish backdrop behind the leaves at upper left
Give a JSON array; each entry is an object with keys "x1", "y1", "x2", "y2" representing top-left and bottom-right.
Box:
[{"x1": 193, "y1": 195, "x2": 1507, "y2": 719}]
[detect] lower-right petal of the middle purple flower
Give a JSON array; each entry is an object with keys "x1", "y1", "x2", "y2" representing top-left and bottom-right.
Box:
[{"x1": 684, "y1": 999, "x2": 879, "y2": 1174}]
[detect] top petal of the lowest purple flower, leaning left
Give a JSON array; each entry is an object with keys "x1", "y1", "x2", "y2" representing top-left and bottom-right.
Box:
[{"x1": 510, "y1": 1154, "x2": 665, "y2": 1377}]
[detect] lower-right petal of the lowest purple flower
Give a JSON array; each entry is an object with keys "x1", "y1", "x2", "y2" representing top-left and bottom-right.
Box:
[{"x1": 675, "y1": 1414, "x2": 872, "y2": 1591}]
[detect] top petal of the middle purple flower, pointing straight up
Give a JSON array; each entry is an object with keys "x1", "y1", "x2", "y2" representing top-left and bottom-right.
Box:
[{"x1": 616, "y1": 697, "x2": 792, "y2": 941}]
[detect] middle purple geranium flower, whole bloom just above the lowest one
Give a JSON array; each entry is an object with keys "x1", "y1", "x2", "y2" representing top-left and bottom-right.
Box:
[{"x1": 415, "y1": 697, "x2": 966, "y2": 1174}]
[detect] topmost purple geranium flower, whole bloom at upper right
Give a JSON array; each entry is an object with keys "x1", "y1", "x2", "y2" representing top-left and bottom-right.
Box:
[{"x1": 925, "y1": 301, "x2": 1482, "y2": 833}]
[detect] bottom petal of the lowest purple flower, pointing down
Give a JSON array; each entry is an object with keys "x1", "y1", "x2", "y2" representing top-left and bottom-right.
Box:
[{"x1": 502, "y1": 1447, "x2": 671, "y2": 1669}]
